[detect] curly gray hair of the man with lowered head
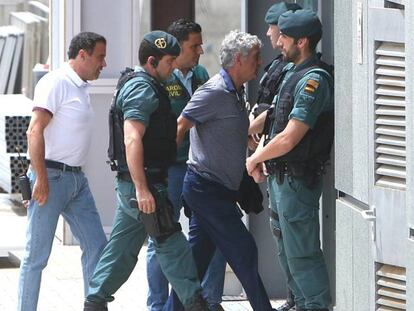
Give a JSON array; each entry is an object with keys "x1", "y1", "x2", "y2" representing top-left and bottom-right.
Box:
[{"x1": 220, "y1": 30, "x2": 262, "y2": 69}]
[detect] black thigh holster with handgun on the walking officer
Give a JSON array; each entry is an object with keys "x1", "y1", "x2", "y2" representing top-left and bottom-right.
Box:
[{"x1": 129, "y1": 184, "x2": 181, "y2": 242}]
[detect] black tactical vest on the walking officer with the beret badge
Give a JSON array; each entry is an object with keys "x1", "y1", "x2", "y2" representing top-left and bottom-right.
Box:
[{"x1": 108, "y1": 68, "x2": 177, "y2": 172}]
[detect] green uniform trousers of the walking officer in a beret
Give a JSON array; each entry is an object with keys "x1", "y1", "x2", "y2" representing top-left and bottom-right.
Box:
[{"x1": 87, "y1": 179, "x2": 201, "y2": 306}]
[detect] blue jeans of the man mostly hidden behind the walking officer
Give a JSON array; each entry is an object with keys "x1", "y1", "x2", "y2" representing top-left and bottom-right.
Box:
[{"x1": 147, "y1": 163, "x2": 226, "y2": 311}]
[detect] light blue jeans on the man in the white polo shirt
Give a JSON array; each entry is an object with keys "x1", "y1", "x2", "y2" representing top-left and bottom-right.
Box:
[{"x1": 17, "y1": 168, "x2": 106, "y2": 311}]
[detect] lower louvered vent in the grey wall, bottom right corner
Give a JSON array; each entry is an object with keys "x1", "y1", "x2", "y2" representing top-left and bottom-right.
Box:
[{"x1": 375, "y1": 264, "x2": 407, "y2": 311}]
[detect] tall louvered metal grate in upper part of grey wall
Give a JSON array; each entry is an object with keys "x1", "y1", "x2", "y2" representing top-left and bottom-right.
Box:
[{"x1": 375, "y1": 42, "x2": 407, "y2": 190}]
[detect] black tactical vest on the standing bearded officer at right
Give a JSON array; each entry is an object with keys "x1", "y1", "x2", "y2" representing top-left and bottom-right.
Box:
[{"x1": 266, "y1": 61, "x2": 334, "y2": 166}]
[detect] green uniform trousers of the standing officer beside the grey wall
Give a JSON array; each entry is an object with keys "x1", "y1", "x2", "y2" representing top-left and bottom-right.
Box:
[{"x1": 268, "y1": 174, "x2": 331, "y2": 309}]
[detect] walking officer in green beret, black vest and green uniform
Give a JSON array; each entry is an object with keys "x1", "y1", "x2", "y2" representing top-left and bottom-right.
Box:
[{"x1": 84, "y1": 31, "x2": 208, "y2": 311}]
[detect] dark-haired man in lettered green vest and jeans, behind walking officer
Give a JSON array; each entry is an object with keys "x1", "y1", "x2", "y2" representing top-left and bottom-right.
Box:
[{"x1": 147, "y1": 18, "x2": 226, "y2": 311}]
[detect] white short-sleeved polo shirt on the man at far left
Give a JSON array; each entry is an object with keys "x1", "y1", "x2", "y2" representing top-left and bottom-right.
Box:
[{"x1": 33, "y1": 63, "x2": 94, "y2": 166}]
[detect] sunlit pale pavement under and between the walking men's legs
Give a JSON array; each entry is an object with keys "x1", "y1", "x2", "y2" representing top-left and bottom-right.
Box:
[{"x1": 0, "y1": 195, "x2": 281, "y2": 311}]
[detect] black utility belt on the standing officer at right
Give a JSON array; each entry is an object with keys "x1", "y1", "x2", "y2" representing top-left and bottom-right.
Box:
[{"x1": 265, "y1": 159, "x2": 326, "y2": 188}]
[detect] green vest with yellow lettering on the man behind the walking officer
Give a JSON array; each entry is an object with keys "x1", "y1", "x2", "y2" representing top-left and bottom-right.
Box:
[{"x1": 165, "y1": 65, "x2": 209, "y2": 163}]
